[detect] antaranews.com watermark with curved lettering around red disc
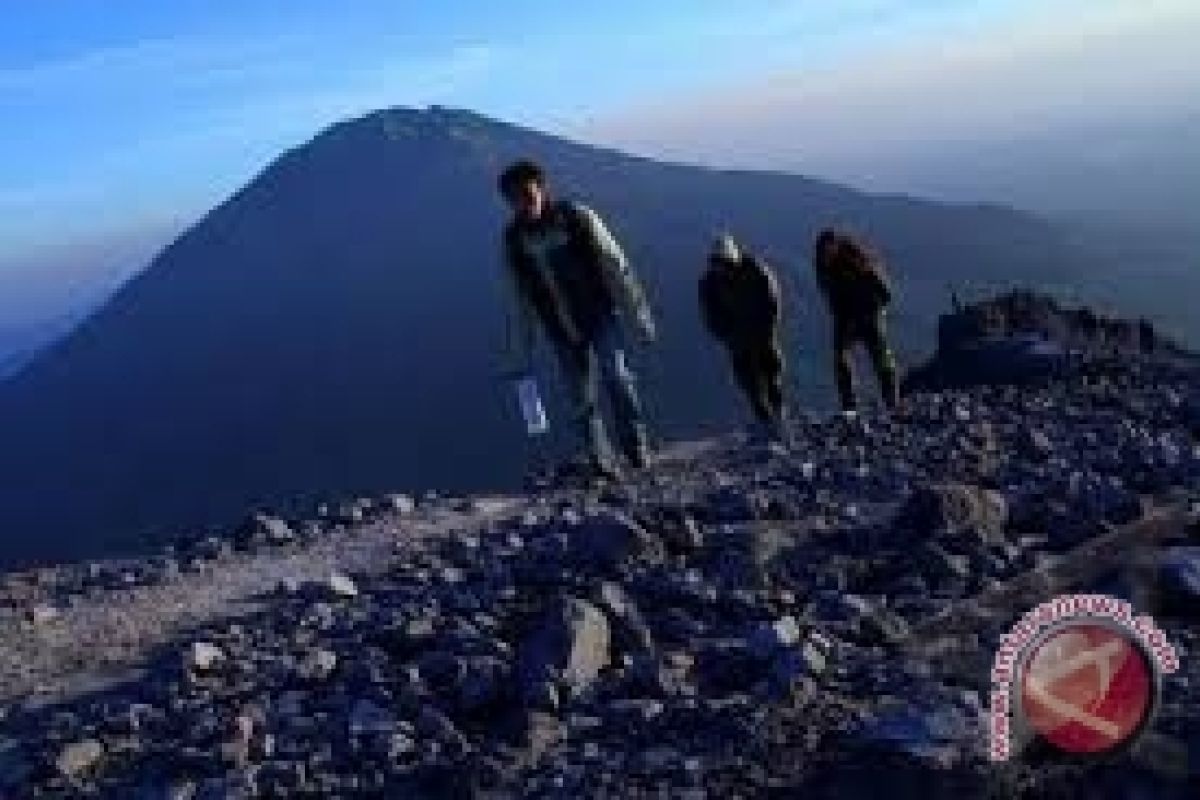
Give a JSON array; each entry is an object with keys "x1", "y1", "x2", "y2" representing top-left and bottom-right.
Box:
[{"x1": 989, "y1": 595, "x2": 1178, "y2": 760}]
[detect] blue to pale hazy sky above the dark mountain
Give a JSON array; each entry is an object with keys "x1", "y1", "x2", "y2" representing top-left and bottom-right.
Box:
[{"x1": 0, "y1": 0, "x2": 1200, "y2": 325}]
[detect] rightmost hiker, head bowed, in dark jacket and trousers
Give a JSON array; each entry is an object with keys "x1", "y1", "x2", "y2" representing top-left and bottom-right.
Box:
[{"x1": 812, "y1": 229, "x2": 900, "y2": 411}]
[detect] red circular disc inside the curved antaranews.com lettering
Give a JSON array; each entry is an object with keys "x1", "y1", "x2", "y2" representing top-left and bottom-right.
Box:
[{"x1": 1020, "y1": 622, "x2": 1154, "y2": 753}]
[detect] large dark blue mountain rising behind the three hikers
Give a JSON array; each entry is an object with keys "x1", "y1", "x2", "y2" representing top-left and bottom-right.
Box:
[{"x1": 0, "y1": 108, "x2": 1094, "y2": 561}]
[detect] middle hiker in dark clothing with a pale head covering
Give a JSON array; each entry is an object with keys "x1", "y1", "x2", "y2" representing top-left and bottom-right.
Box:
[{"x1": 700, "y1": 235, "x2": 784, "y2": 437}]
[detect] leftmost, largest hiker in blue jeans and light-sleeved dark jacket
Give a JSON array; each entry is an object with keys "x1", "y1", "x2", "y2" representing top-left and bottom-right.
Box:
[{"x1": 499, "y1": 161, "x2": 655, "y2": 479}]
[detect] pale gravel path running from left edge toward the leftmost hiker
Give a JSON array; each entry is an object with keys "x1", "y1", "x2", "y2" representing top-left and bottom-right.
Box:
[{"x1": 0, "y1": 498, "x2": 515, "y2": 705}]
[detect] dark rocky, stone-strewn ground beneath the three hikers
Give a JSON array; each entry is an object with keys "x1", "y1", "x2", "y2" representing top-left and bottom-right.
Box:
[{"x1": 0, "y1": 359, "x2": 1200, "y2": 799}]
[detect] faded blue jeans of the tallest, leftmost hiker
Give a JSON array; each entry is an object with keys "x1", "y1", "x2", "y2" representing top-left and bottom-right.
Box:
[{"x1": 556, "y1": 320, "x2": 648, "y2": 464}]
